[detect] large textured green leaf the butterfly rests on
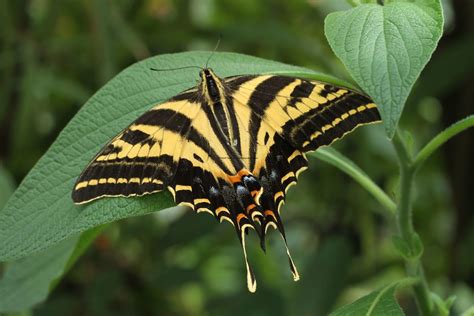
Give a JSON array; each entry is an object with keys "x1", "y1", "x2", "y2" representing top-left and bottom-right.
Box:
[{"x1": 0, "y1": 52, "x2": 342, "y2": 261}]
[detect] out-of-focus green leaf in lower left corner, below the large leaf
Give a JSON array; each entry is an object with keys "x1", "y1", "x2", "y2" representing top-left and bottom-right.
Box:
[{"x1": 0, "y1": 236, "x2": 78, "y2": 312}]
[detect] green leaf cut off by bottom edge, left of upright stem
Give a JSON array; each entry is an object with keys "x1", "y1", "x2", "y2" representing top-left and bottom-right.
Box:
[{"x1": 331, "y1": 282, "x2": 404, "y2": 316}]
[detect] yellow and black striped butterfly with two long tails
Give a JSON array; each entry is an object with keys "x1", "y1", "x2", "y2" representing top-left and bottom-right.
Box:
[{"x1": 72, "y1": 68, "x2": 380, "y2": 292}]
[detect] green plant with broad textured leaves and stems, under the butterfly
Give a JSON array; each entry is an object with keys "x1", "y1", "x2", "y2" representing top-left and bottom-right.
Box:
[{"x1": 0, "y1": 0, "x2": 474, "y2": 315}]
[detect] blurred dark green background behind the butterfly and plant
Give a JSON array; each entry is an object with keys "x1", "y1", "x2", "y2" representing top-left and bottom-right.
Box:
[{"x1": 0, "y1": 0, "x2": 474, "y2": 315}]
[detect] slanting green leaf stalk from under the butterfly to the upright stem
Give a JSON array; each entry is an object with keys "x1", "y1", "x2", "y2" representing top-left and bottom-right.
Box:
[{"x1": 309, "y1": 147, "x2": 397, "y2": 215}]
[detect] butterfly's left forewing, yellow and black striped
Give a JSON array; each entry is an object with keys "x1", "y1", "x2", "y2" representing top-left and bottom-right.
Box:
[{"x1": 72, "y1": 91, "x2": 204, "y2": 204}]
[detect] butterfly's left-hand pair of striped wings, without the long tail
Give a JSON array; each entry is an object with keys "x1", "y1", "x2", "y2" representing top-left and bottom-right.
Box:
[{"x1": 72, "y1": 86, "x2": 244, "y2": 224}]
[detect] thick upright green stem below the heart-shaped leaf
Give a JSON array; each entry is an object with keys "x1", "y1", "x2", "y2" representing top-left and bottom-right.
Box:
[{"x1": 392, "y1": 131, "x2": 433, "y2": 315}]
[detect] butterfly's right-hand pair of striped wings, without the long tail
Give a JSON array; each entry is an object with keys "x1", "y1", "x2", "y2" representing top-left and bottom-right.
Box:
[{"x1": 227, "y1": 75, "x2": 380, "y2": 227}]
